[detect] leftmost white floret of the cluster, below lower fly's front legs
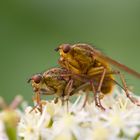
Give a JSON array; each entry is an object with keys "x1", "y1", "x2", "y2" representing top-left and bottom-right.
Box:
[{"x1": 18, "y1": 107, "x2": 50, "y2": 140}]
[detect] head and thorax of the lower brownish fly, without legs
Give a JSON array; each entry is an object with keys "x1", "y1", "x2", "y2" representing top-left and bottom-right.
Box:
[{"x1": 29, "y1": 67, "x2": 84, "y2": 97}]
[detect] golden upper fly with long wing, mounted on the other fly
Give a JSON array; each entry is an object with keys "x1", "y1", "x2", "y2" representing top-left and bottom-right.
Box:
[{"x1": 55, "y1": 43, "x2": 140, "y2": 109}]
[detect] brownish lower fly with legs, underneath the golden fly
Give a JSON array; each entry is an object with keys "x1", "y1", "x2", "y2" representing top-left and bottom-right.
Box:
[{"x1": 28, "y1": 67, "x2": 112, "y2": 111}]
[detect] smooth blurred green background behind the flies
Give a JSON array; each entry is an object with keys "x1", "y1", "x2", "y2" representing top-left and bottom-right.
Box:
[{"x1": 0, "y1": 0, "x2": 140, "y2": 101}]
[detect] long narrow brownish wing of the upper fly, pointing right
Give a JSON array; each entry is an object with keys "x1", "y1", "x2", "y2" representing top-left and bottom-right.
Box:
[{"x1": 93, "y1": 49, "x2": 140, "y2": 78}]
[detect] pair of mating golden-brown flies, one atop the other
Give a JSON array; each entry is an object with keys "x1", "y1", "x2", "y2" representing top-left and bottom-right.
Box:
[{"x1": 29, "y1": 44, "x2": 140, "y2": 110}]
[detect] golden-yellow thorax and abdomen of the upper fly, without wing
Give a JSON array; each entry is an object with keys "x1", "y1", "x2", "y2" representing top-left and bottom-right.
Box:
[{"x1": 56, "y1": 44, "x2": 114, "y2": 94}]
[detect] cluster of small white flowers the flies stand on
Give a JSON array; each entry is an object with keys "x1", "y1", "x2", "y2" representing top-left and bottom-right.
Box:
[{"x1": 17, "y1": 90, "x2": 140, "y2": 140}]
